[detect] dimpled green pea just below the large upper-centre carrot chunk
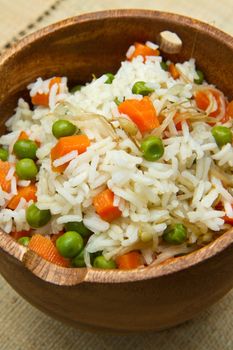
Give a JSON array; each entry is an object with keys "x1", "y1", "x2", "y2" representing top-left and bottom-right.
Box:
[{"x1": 141, "y1": 136, "x2": 164, "y2": 162}]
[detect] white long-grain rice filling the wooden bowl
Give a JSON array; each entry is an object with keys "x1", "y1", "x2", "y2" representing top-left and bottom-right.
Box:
[{"x1": 0, "y1": 40, "x2": 233, "y2": 266}]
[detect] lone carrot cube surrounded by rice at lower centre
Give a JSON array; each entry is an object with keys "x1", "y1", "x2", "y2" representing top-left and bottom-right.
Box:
[{"x1": 93, "y1": 189, "x2": 121, "y2": 222}]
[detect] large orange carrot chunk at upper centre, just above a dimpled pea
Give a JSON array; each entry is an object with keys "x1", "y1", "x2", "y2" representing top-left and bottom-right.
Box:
[{"x1": 118, "y1": 96, "x2": 159, "y2": 132}]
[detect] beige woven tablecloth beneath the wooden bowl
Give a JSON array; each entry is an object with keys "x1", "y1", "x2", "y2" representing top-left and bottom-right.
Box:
[{"x1": 0, "y1": 0, "x2": 233, "y2": 350}]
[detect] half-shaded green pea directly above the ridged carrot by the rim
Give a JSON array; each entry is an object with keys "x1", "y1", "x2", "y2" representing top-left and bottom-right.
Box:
[{"x1": 26, "y1": 204, "x2": 51, "y2": 228}]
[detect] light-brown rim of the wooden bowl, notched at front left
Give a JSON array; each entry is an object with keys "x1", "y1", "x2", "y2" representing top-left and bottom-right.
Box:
[{"x1": 0, "y1": 9, "x2": 233, "y2": 286}]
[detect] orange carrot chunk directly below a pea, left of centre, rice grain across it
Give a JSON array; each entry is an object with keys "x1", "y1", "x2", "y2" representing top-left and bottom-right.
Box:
[{"x1": 51, "y1": 135, "x2": 90, "y2": 172}]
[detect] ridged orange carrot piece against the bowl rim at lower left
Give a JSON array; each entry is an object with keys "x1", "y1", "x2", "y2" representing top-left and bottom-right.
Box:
[{"x1": 28, "y1": 234, "x2": 69, "y2": 267}]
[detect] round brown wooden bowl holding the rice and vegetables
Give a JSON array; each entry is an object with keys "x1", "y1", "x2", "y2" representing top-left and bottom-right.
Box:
[{"x1": 0, "y1": 10, "x2": 233, "y2": 332}]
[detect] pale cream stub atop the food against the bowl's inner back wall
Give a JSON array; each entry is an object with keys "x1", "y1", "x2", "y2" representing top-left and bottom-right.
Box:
[{"x1": 159, "y1": 30, "x2": 182, "y2": 54}]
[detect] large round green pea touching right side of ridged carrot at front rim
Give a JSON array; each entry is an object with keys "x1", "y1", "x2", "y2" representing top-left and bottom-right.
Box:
[{"x1": 56, "y1": 231, "x2": 83, "y2": 258}]
